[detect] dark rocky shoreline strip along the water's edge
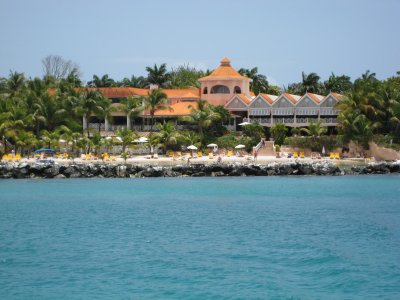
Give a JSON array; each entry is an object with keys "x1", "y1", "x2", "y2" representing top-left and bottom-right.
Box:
[{"x1": 0, "y1": 161, "x2": 400, "y2": 179}]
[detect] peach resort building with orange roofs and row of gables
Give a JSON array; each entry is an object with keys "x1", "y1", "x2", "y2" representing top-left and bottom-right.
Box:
[{"x1": 84, "y1": 58, "x2": 342, "y2": 133}]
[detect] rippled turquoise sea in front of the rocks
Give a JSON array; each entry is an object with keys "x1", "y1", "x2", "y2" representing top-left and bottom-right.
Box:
[{"x1": 0, "y1": 176, "x2": 400, "y2": 299}]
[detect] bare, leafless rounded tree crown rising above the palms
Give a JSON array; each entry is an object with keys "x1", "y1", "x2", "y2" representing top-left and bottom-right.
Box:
[{"x1": 42, "y1": 55, "x2": 80, "y2": 80}]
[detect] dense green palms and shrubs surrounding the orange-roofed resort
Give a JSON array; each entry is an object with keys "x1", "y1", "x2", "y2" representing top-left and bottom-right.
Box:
[{"x1": 0, "y1": 57, "x2": 400, "y2": 154}]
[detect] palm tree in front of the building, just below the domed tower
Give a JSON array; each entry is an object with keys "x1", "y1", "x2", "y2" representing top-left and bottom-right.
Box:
[{"x1": 182, "y1": 99, "x2": 221, "y2": 144}]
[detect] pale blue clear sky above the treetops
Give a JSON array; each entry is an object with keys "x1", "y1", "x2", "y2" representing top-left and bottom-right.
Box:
[{"x1": 0, "y1": 0, "x2": 400, "y2": 86}]
